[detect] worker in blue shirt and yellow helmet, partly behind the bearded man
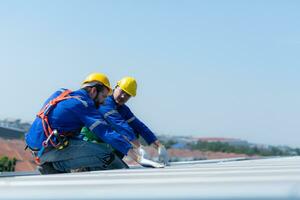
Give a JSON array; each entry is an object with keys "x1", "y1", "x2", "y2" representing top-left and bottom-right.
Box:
[{"x1": 85, "y1": 77, "x2": 169, "y2": 165}]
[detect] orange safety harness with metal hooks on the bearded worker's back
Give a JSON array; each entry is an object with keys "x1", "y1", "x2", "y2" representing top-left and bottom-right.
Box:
[{"x1": 33, "y1": 90, "x2": 74, "y2": 165}]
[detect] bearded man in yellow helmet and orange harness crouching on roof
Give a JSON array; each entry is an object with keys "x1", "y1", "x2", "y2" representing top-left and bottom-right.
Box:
[{"x1": 25, "y1": 73, "x2": 160, "y2": 174}]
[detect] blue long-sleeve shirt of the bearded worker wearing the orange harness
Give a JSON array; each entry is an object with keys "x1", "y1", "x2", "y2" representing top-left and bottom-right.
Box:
[{"x1": 25, "y1": 89, "x2": 132, "y2": 155}]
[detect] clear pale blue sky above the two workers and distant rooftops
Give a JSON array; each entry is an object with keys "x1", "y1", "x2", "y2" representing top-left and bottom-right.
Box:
[{"x1": 0, "y1": 0, "x2": 300, "y2": 146}]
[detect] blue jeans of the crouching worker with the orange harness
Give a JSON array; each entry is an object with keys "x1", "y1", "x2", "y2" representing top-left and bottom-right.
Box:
[{"x1": 40, "y1": 139, "x2": 128, "y2": 173}]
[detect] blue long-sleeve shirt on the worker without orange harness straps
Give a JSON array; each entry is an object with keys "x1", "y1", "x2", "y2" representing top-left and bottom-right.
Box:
[{"x1": 99, "y1": 96, "x2": 157, "y2": 144}]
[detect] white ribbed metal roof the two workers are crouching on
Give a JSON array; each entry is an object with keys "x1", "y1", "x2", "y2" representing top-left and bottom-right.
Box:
[{"x1": 0, "y1": 156, "x2": 300, "y2": 199}]
